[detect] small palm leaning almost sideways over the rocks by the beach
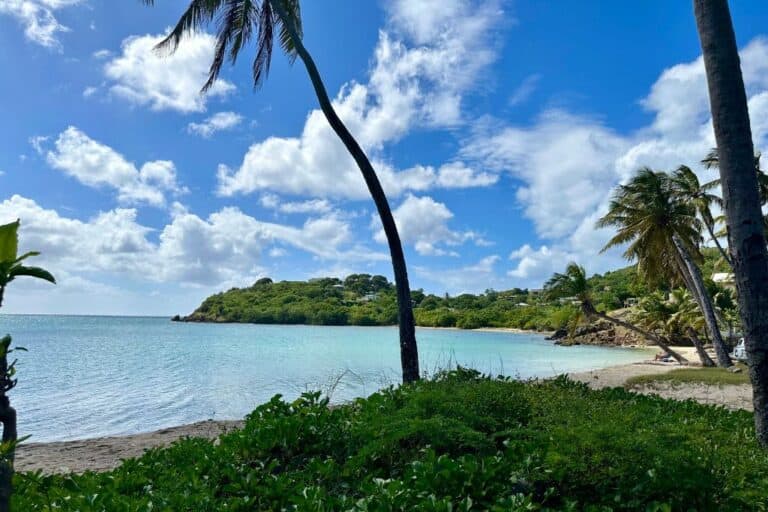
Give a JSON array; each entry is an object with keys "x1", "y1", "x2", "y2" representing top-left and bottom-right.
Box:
[{"x1": 544, "y1": 263, "x2": 688, "y2": 364}]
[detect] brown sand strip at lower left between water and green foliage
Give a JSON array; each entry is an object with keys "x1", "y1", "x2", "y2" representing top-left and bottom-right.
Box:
[{"x1": 15, "y1": 421, "x2": 242, "y2": 473}]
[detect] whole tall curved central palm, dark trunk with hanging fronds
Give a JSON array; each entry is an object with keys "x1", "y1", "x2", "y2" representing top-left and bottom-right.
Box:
[{"x1": 142, "y1": 0, "x2": 419, "y2": 382}]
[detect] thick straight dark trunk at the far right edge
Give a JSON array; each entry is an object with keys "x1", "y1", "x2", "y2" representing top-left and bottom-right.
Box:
[{"x1": 693, "y1": 0, "x2": 768, "y2": 447}]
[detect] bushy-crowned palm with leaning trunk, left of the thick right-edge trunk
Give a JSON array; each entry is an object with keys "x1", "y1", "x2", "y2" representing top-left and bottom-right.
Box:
[{"x1": 597, "y1": 167, "x2": 731, "y2": 367}]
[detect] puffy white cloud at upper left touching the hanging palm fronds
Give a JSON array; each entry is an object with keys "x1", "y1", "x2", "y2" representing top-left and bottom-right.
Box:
[{"x1": 104, "y1": 33, "x2": 235, "y2": 114}]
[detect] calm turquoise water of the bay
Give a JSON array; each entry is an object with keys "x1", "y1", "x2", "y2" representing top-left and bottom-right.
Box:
[{"x1": 0, "y1": 315, "x2": 647, "y2": 441}]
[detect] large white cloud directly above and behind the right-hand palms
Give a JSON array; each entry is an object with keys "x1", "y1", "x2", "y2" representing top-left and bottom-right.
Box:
[{"x1": 480, "y1": 38, "x2": 768, "y2": 286}]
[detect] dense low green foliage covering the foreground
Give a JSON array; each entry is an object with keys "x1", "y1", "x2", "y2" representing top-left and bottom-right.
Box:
[{"x1": 14, "y1": 369, "x2": 768, "y2": 512}]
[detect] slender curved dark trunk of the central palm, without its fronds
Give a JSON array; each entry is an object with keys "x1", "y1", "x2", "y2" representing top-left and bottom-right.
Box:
[{"x1": 272, "y1": 0, "x2": 419, "y2": 383}]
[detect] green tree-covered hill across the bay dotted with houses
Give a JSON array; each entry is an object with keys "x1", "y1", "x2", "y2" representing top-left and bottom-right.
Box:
[{"x1": 175, "y1": 267, "x2": 684, "y2": 331}]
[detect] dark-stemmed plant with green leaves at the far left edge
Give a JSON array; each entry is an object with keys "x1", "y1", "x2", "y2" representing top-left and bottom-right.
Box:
[{"x1": 0, "y1": 220, "x2": 56, "y2": 512}]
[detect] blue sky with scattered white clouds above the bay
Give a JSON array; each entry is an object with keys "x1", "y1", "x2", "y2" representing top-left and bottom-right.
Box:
[{"x1": 0, "y1": 0, "x2": 768, "y2": 315}]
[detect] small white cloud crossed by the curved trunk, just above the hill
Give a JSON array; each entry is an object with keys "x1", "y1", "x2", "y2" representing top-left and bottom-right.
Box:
[{"x1": 371, "y1": 194, "x2": 479, "y2": 256}]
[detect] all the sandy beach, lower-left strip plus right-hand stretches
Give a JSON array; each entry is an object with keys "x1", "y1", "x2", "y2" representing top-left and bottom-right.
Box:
[{"x1": 16, "y1": 346, "x2": 752, "y2": 473}]
